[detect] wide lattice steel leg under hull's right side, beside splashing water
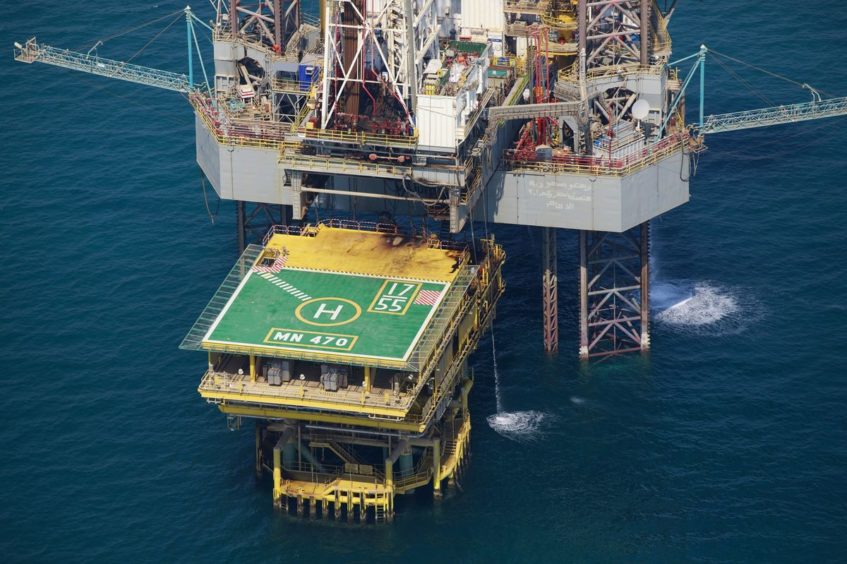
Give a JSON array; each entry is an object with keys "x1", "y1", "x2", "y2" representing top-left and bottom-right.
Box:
[{"x1": 579, "y1": 223, "x2": 650, "y2": 359}]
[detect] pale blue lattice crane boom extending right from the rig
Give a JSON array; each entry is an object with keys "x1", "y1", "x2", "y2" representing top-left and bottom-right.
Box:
[{"x1": 696, "y1": 97, "x2": 847, "y2": 135}]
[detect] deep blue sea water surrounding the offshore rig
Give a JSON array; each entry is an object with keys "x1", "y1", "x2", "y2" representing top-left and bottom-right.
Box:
[{"x1": 0, "y1": 0, "x2": 847, "y2": 562}]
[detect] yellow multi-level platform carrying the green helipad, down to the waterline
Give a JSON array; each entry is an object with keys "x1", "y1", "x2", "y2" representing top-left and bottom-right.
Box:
[{"x1": 182, "y1": 222, "x2": 505, "y2": 522}]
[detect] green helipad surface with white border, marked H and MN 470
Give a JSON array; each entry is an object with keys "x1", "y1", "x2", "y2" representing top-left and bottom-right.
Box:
[{"x1": 202, "y1": 268, "x2": 449, "y2": 362}]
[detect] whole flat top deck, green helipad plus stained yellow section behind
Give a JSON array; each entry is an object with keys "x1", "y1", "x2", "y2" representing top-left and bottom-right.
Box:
[{"x1": 194, "y1": 226, "x2": 465, "y2": 366}]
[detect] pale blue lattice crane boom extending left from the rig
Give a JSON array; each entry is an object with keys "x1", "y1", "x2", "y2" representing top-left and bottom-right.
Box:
[{"x1": 15, "y1": 37, "x2": 191, "y2": 92}]
